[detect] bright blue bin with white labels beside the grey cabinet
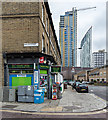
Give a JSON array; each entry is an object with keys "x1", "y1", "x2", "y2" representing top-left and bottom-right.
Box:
[{"x1": 34, "y1": 90, "x2": 44, "y2": 104}]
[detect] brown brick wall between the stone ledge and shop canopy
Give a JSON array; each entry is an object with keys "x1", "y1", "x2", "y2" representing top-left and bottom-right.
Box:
[{"x1": 2, "y1": 17, "x2": 39, "y2": 53}]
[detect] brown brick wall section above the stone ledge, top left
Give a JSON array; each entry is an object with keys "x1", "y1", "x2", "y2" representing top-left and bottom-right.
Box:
[{"x1": 2, "y1": 2, "x2": 39, "y2": 15}]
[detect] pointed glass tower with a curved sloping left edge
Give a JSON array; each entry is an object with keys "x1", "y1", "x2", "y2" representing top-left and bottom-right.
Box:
[{"x1": 80, "y1": 27, "x2": 92, "y2": 67}]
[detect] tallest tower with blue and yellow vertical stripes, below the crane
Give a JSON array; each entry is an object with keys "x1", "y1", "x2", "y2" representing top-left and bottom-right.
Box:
[{"x1": 59, "y1": 8, "x2": 77, "y2": 67}]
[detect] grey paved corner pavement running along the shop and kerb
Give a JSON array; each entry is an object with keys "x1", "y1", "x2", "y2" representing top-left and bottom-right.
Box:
[{"x1": 0, "y1": 86, "x2": 107, "y2": 114}]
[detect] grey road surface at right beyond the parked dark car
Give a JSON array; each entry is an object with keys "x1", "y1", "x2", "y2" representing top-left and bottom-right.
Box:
[{"x1": 89, "y1": 85, "x2": 108, "y2": 101}]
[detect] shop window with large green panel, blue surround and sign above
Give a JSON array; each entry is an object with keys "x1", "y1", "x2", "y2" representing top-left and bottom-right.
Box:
[{"x1": 8, "y1": 64, "x2": 34, "y2": 88}]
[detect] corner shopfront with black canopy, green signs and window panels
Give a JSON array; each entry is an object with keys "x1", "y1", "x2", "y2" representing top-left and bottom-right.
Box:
[{"x1": 4, "y1": 53, "x2": 56, "y2": 99}]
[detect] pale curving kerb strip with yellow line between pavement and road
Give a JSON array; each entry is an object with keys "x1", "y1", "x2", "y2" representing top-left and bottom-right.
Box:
[{"x1": 0, "y1": 109, "x2": 107, "y2": 115}]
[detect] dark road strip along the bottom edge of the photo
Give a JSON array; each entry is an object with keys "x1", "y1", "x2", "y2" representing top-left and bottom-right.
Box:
[{"x1": 2, "y1": 111, "x2": 107, "y2": 120}]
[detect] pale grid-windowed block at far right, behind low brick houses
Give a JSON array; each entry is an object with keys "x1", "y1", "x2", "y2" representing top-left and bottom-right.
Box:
[{"x1": 92, "y1": 50, "x2": 106, "y2": 68}]
